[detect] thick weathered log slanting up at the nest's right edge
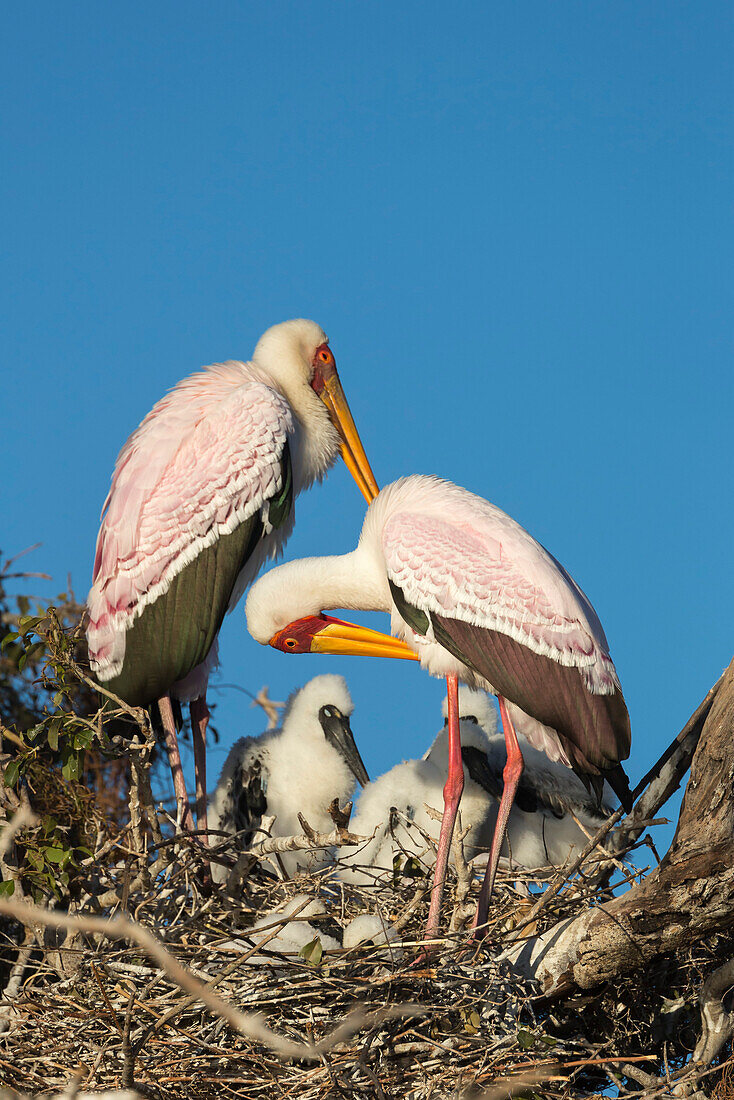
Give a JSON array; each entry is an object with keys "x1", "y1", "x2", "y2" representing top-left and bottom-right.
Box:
[{"x1": 505, "y1": 661, "x2": 734, "y2": 998}]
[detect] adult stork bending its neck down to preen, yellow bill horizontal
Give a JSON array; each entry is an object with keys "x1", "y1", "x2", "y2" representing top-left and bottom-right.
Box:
[{"x1": 247, "y1": 475, "x2": 629, "y2": 938}]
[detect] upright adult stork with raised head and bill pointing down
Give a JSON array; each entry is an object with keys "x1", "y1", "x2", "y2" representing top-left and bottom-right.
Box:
[{"x1": 87, "y1": 320, "x2": 377, "y2": 836}]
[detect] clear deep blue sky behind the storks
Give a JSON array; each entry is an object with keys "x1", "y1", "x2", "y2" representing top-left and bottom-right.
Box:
[{"x1": 0, "y1": 0, "x2": 734, "y2": 849}]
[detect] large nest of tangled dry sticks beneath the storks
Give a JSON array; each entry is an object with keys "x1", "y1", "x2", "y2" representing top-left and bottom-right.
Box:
[{"x1": 0, "y1": 787, "x2": 731, "y2": 1100}]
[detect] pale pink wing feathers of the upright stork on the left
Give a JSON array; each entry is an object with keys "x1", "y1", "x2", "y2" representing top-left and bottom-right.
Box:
[{"x1": 87, "y1": 362, "x2": 293, "y2": 680}]
